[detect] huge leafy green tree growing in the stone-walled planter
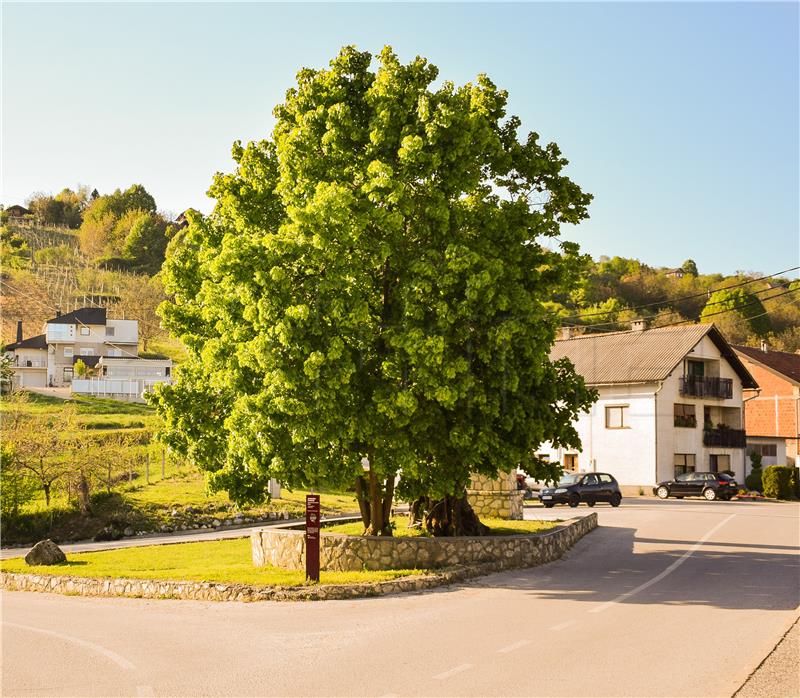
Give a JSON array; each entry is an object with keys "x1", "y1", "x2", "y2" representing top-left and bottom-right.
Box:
[{"x1": 153, "y1": 48, "x2": 593, "y2": 535}]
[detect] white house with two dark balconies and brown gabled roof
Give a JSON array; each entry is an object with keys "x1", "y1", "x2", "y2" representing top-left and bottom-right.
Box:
[{"x1": 538, "y1": 325, "x2": 758, "y2": 494}]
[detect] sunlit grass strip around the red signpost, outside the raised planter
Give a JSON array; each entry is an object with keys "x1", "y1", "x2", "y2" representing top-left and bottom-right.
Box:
[{"x1": 0, "y1": 538, "x2": 424, "y2": 586}]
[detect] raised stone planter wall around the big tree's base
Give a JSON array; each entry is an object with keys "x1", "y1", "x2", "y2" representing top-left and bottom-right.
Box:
[{"x1": 250, "y1": 513, "x2": 597, "y2": 572}]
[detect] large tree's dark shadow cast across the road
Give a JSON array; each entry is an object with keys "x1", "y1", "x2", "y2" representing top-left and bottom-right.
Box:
[{"x1": 450, "y1": 527, "x2": 800, "y2": 610}]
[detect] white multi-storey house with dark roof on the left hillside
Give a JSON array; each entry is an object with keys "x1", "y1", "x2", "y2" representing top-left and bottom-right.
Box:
[{"x1": 6, "y1": 308, "x2": 172, "y2": 400}]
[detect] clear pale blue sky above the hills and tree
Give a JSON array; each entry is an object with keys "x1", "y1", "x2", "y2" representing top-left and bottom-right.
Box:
[{"x1": 1, "y1": 2, "x2": 800, "y2": 273}]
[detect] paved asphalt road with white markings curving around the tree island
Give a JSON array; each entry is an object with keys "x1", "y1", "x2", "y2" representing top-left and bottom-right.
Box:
[{"x1": 2, "y1": 499, "x2": 800, "y2": 696}]
